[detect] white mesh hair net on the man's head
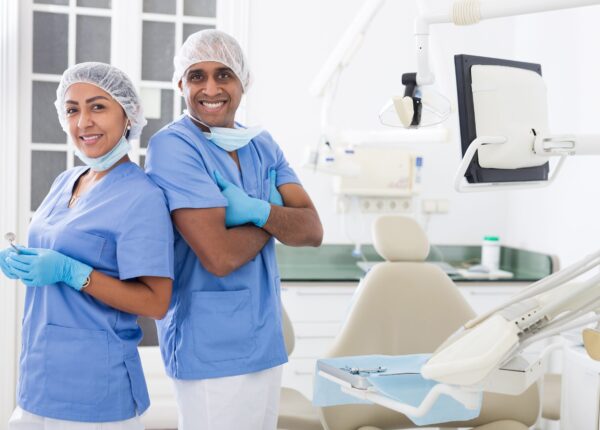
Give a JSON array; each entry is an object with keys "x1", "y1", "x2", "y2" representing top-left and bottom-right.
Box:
[{"x1": 173, "y1": 29, "x2": 250, "y2": 92}]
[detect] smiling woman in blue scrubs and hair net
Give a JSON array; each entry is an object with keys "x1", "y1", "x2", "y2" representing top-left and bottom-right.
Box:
[{"x1": 0, "y1": 63, "x2": 173, "y2": 430}]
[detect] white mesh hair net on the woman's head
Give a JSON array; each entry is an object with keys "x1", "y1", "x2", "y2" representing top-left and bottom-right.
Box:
[{"x1": 54, "y1": 62, "x2": 147, "y2": 139}]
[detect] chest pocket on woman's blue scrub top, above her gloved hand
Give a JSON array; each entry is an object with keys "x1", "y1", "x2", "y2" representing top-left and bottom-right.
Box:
[{"x1": 52, "y1": 226, "x2": 106, "y2": 269}]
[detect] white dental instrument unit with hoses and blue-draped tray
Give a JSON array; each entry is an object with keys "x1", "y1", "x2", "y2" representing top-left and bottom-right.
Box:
[{"x1": 318, "y1": 227, "x2": 600, "y2": 424}]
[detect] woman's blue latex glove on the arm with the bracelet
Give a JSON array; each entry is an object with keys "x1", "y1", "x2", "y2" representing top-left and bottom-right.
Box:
[{"x1": 6, "y1": 248, "x2": 93, "y2": 291}]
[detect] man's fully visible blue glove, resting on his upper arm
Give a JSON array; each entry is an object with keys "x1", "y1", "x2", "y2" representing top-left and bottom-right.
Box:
[{"x1": 215, "y1": 171, "x2": 271, "y2": 227}]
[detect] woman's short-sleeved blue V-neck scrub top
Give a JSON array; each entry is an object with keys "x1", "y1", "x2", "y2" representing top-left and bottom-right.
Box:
[{"x1": 17, "y1": 162, "x2": 173, "y2": 422}]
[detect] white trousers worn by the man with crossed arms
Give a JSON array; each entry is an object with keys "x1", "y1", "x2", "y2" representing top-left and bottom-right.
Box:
[{"x1": 173, "y1": 366, "x2": 282, "y2": 430}]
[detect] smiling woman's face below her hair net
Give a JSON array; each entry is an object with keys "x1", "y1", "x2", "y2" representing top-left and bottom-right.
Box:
[{"x1": 64, "y1": 82, "x2": 127, "y2": 158}]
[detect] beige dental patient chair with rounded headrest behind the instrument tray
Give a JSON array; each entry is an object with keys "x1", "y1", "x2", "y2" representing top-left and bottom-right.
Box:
[{"x1": 320, "y1": 216, "x2": 540, "y2": 430}]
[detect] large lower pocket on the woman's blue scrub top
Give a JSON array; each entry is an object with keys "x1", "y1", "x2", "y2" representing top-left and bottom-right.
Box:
[{"x1": 44, "y1": 324, "x2": 109, "y2": 405}]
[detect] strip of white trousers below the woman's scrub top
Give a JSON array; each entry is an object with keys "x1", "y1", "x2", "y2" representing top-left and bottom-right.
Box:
[{"x1": 8, "y1": 407, "x2": 144, "y2": 430}]
